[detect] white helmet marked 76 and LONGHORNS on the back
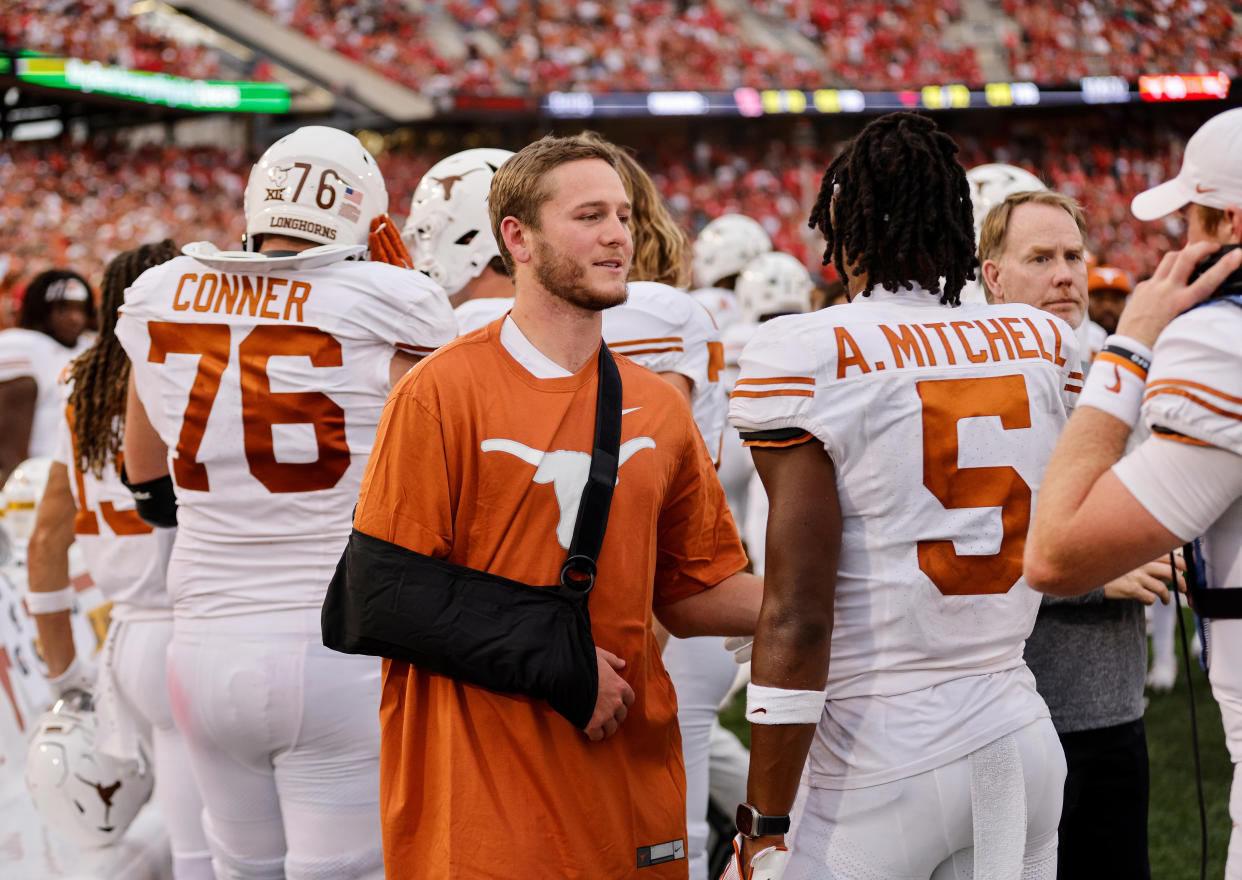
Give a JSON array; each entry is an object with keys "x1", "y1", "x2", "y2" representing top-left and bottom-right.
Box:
[{"x1": 242, "y1": 125, "x2": 388, "y2": 251}]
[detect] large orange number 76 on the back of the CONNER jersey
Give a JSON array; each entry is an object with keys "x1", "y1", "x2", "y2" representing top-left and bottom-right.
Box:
[{"x1": 147, "y1": 321, "x2": 350, "y2": 493}]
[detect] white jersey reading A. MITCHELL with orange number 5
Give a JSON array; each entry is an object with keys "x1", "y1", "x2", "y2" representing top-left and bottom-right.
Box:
[{"x1": 729, "y1": 289, "x2": 1082, "y2": 699}]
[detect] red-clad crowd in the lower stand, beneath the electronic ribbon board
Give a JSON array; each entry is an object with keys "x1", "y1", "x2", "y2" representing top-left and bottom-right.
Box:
[{"x1": 0, "y1": 123, "x2": 1184, "y2": 324}]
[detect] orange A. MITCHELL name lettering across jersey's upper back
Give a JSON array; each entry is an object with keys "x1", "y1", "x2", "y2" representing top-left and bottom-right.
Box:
[{"x1": 832, "y1": 315, "x2": 1071, "y2": 379}]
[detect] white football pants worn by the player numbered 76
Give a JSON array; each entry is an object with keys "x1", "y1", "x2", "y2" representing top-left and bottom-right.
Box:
[{"x1": 169, "y1": 616, "x2": 384, "y2": 880}]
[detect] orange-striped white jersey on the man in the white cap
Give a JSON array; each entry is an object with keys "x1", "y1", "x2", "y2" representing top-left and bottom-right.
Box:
[{"x1": 1143, "y1": 302, "x2": 1242, "y2": 587}]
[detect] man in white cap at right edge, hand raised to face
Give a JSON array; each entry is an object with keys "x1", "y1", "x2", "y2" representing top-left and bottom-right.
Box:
[{"x1": 1026, "y1": 109, "x2": 1242, "y2": 880}]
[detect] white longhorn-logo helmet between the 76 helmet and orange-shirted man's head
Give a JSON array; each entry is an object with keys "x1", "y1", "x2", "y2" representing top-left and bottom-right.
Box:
[{"x1": 401, "y1": 146, "x2": 513, "y2": 295}]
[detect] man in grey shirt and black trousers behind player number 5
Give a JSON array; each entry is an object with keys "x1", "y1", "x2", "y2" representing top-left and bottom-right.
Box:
[{"x1": 979, "y1": 191, "x2": 1171, "y2": 880}]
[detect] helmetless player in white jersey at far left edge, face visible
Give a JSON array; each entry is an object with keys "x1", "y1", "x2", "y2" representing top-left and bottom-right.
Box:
[{"x1": 0, "y1": 269, "x2": 96, "y2": 485}]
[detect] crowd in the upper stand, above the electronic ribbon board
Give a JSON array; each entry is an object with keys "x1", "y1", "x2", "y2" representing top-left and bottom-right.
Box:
[{"x1": 0, "y1": 0, "x2": 1242, "y2": 97}]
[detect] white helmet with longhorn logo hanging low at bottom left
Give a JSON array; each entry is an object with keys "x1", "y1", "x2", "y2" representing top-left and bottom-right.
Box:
[{"x1": 26, "y1": 690, "x2": 154, "y2": 846}]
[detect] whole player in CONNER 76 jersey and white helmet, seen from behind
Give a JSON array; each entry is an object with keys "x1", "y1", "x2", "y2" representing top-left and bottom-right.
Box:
[{"x1": 117, "y1": 125, "x2": 456, "y2": 880}]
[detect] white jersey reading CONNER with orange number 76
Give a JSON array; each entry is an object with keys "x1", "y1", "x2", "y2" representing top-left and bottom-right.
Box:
[{"x1": 117, "y1": 250, "x2": 456, "y2": 617}]
